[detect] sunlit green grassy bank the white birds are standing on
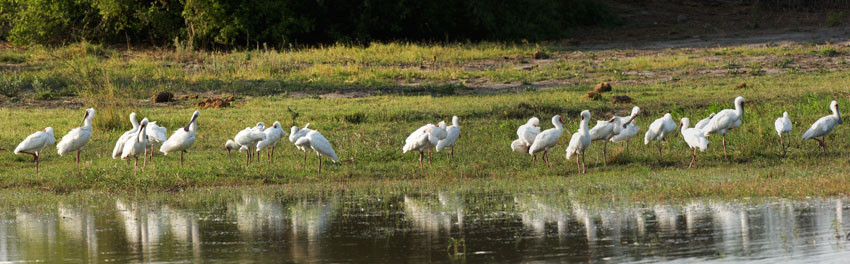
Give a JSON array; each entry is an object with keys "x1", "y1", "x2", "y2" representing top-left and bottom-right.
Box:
[{"x1": 0, "y1": 42, "x2": 850, "y2": 200}]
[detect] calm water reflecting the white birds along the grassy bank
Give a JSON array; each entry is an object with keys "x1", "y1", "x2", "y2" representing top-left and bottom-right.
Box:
[{"x1": 0, "y1": 191, "x2": 850, "y2": 263}]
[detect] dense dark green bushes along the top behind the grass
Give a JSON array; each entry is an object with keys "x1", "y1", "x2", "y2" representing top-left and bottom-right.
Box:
[{"x1": 0, "y1": 0, "x2": 611, "y2": 47}]
